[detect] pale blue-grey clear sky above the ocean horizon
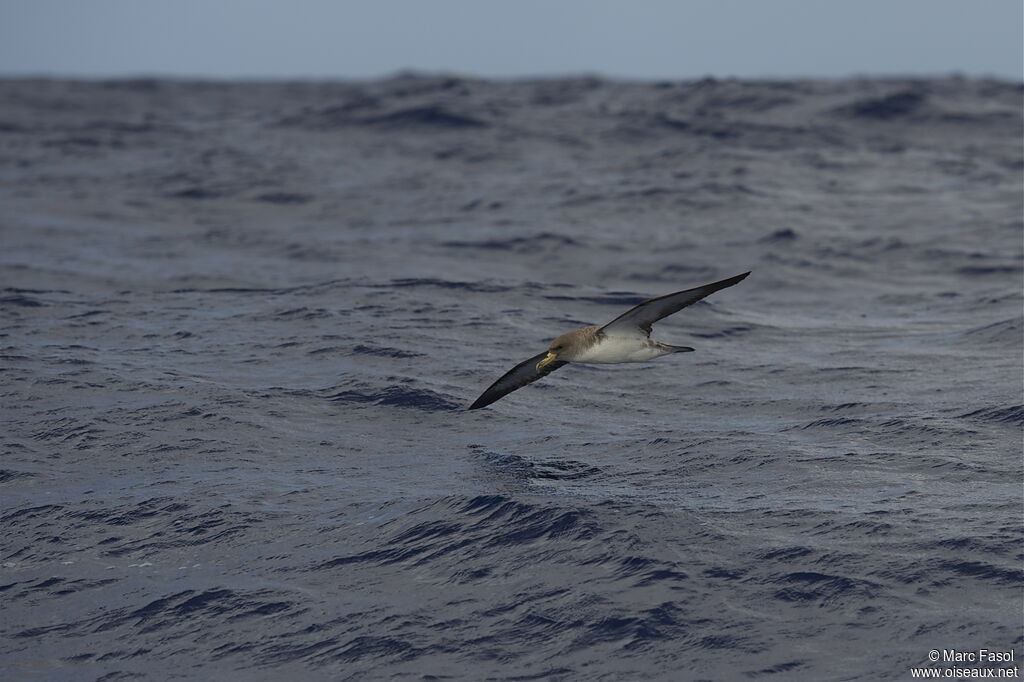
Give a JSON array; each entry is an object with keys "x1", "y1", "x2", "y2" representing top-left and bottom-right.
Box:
[{"x1": 0, "y1": 0, "x2": 1024, "y2": 80}]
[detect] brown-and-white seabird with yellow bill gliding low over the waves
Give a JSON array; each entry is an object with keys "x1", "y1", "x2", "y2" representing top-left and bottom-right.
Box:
[{"x1": 469, "y1": 272, "x2": 750, "y2": 410}]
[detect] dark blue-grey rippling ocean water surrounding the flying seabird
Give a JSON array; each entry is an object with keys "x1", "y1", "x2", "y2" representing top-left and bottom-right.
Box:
[{"x1": 0, "y1": 75, "x2": 1024, "y2": 681}]
